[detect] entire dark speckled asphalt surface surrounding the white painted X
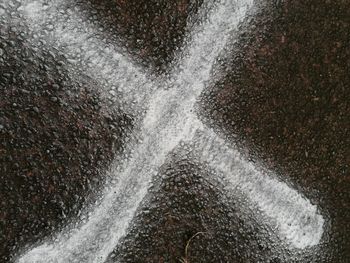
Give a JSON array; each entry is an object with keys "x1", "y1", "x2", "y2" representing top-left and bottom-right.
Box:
[{"x1": 0, "y1": 0, "x2": 350, "y2": 263}]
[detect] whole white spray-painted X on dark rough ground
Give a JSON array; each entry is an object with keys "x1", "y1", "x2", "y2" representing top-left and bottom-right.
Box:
[{"x1": 13, "y1": 0, "x2": 324, "y2": 263}]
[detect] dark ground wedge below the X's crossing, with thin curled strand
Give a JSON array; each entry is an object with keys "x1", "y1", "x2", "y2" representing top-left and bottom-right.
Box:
[{"x1": 108, "y1": 152, "x2": 306, "y2": 263}]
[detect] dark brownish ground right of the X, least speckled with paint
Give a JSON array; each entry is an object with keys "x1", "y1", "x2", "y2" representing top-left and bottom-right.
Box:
[{"x1": 203, "y1": 1, "x2": 350, "y2": 262}]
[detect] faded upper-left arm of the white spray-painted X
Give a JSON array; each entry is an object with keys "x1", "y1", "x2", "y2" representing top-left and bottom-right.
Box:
[{"x1": 19, "y1": 0, "x2": 157, "y2": 112}]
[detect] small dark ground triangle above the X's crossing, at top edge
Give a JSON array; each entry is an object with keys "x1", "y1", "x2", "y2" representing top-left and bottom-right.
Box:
[{"x1": 80, "y1": 0, "x2": 203, "y2": 72}]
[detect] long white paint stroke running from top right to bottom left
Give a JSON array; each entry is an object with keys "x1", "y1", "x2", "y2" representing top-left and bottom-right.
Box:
[{"x1": 17, "y1": 1, "x2": 251, "y2": 263}]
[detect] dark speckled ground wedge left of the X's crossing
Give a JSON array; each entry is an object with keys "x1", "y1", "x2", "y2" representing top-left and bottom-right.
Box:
[{"x1": 0, "y1": 22, "x2": 131, "y2": 262}]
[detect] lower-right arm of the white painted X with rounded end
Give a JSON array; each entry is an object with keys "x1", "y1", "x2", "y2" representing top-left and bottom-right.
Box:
[{"x1": 195, "y1": 129, "x2": 324, "y2": 249}]
